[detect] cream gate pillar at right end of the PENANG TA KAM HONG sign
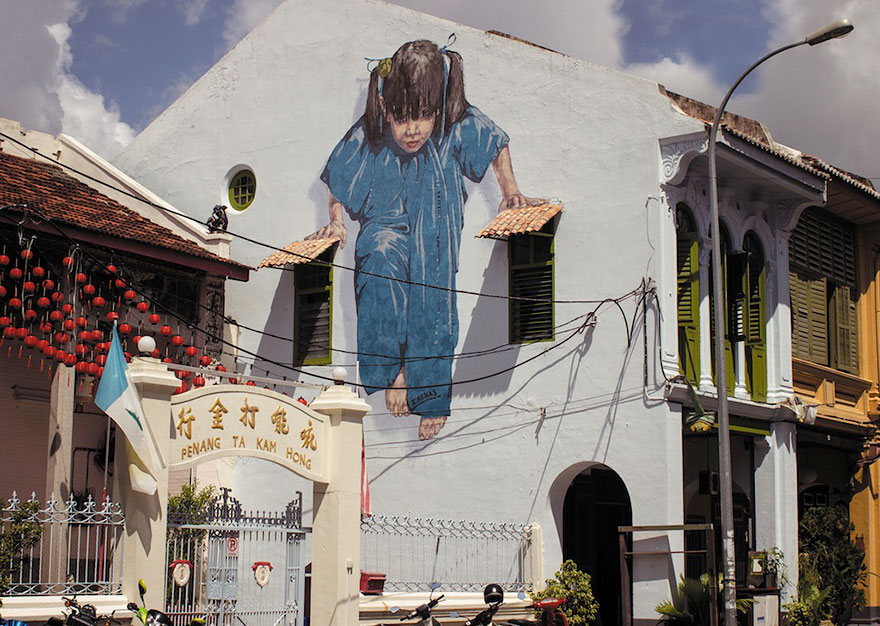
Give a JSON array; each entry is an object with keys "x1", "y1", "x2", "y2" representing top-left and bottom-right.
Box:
[{"x1": 309, "y1": 368, "x2": 370, "y2": 626}]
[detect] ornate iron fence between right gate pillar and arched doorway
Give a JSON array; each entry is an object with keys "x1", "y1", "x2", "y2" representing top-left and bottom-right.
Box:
[{"x1": 361, "y1": 515, "x2": 540, "y2": 592}]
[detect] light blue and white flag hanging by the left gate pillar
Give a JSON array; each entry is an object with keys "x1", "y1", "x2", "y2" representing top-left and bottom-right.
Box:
[{"x1": 95, "y1": 323, "x2": 163, "y2": 494}]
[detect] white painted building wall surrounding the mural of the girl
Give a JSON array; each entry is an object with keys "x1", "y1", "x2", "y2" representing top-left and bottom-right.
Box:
[{"x1": 110, "y1": 0, "x2": 804, "y2": 620}]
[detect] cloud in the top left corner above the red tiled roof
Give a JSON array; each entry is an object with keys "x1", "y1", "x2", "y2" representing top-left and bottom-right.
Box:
[{"x1": 0, "y1": 0, "x2": 134, "y2": 158}]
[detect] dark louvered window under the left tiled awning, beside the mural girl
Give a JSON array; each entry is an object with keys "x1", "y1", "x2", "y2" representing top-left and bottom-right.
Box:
[{"x1": 293, "y1": 248, "x2": 333, "y2": 365}]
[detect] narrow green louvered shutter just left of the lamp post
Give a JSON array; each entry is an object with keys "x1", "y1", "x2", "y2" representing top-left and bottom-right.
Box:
[{"x1": 677, "y1": 236, "x2": 700, "y2": 385}]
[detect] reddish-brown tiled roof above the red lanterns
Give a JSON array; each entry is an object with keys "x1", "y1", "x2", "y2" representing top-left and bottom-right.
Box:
[{"x1": 0, "y1": 152, "x2": 247, "y2": 271}]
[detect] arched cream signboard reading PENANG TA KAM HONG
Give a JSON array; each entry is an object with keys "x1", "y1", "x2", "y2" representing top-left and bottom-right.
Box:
[{"x1": 165, "y1": 385, "x2": 327, "y2": 482}]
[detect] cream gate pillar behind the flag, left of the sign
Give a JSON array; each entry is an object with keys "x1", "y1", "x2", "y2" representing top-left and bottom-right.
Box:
[{"x1": 114, "y1": 357, "x2": 180, "y2": 610}]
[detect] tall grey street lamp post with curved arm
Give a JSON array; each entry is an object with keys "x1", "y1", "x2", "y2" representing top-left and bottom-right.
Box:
[{"x1": 708, "y1": 14, "x2": 853, "y2": 626}]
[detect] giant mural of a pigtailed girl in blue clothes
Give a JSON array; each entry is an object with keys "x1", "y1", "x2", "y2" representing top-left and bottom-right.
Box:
[{"x1": 308, "y1": 40, "x2": 527, "y2": 440}]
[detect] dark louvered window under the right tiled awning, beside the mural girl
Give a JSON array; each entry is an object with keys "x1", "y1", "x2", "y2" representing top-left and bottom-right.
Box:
[{"x1": 508, "y1": 220, "x2": 554, "y2": 343}]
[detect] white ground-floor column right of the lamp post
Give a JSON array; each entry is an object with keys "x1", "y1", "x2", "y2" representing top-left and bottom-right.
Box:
[{"x1": 754, "y1": 422, "x2": 798, "y2": 603}]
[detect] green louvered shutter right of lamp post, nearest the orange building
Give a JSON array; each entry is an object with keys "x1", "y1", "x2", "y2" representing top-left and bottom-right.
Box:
[{"x1": 743, "y1": 251, "x2": 767, "y2": 402}]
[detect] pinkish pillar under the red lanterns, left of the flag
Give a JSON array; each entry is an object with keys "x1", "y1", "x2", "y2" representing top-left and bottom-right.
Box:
[{"x1": 46, "y1": 365, "x2": 74, "y2": 502}]
